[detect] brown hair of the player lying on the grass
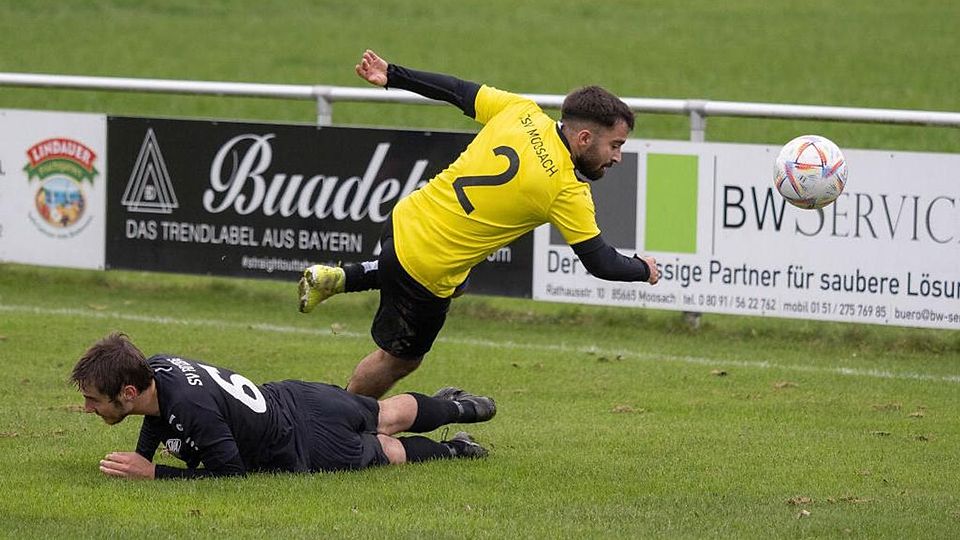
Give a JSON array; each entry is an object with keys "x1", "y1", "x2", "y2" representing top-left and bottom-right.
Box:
[{"x1": 70, "y1": 332, "x2": 153, "y2": 400}]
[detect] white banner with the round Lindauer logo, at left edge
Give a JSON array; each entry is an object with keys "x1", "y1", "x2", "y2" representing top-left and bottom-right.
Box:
[{"x1": 0, "y1": 109, "x2": 107, "y2": 269}]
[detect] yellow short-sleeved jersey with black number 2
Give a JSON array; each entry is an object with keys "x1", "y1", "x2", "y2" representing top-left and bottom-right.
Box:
[{"x1": 393, "y1": 86, "x2": 600, "y2": 298}]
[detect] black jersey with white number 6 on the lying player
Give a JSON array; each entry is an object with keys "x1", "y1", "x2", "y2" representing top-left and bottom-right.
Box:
[{"x1": 137, "y1": 355, "x2": 310, "y2": 478}]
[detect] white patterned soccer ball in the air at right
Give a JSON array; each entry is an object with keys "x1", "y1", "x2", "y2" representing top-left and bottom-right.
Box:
[{"x1": 773, "y1": 135, "x2": 847, "y2": 209}]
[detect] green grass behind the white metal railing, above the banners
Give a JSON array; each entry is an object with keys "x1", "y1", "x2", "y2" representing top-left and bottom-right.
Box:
[{"x1": 0, "y1": 0, "x2": 960, "y2": 152}]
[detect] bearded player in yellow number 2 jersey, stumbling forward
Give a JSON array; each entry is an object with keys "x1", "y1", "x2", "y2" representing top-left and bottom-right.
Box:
[{"x1": 299, "y1": 50, "x2": 660, "y2": 397}]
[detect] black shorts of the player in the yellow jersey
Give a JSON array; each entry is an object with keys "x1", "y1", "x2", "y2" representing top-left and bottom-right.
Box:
[{"x1": 370, "y1": 219, "x2": 450, "y2": 359}]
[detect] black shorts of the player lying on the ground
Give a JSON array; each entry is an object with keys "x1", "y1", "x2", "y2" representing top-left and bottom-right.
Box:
[{"x1": 292, "y1": 381, "x2": 389, "y2": 471}]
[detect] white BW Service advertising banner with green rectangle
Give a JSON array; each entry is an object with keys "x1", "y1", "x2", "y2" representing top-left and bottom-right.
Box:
[{"x1": 533, "y1": 140, "x2": 960, "y2": 329}]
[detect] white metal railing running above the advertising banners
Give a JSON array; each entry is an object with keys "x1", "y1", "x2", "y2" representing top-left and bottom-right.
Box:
[{"x1": 0, "y1": 73, "x2": 960, "y2": 141}]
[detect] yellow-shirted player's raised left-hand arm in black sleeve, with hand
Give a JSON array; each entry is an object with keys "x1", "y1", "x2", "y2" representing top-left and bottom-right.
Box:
[{"x1": 356, "y1": 49, "x2": 480, "y2": 118}]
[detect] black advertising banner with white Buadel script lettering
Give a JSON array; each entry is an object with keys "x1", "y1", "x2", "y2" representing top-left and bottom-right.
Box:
[{"x1": 106, "y1": 117, "x2": 533, "y2": 297}]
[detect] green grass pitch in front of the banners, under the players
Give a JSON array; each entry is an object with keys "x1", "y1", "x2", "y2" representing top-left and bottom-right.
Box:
[{"x1": 0, "y1": 265, "x2": 960, "y2": 538}]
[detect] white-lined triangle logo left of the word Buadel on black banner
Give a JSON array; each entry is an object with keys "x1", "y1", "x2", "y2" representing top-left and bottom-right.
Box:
[{"x1": 121, "y1": 129, "x2": 180, "y2": 214}]
